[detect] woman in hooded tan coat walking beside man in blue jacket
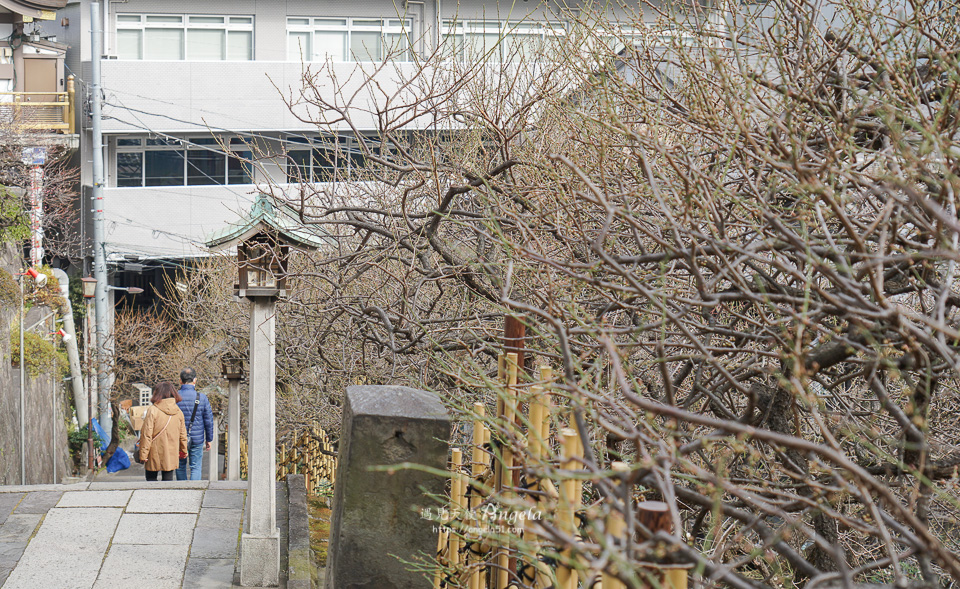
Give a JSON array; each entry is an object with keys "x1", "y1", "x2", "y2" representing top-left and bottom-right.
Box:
[{"x1": 140, "y1": 381, "x2": 187, "y2": 481}]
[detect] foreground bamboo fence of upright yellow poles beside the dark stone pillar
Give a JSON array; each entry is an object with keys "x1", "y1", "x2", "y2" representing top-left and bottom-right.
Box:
[{"x1": 433, "y1": 354, "x2": 687, "y2": 589}]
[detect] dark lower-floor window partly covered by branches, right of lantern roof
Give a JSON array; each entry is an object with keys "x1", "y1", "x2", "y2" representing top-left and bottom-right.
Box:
[{"x1": 287, "y1": 137, "x2": 367, "y2": 184}]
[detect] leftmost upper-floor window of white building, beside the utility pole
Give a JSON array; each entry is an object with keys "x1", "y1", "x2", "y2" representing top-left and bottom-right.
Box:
[{"x1": 117, "y1": 14, "x2": 253, "y2": 61}]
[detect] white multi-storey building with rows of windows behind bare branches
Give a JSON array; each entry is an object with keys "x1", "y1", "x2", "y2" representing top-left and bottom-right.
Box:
[{"x1": 35, "y1": 0, "x2": 684, "y2": 296}]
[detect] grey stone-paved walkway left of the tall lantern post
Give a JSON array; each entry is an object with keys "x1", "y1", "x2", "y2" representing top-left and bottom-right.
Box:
[{"x1": 0, "y1": 475, "x2": 247, "y2": 589}]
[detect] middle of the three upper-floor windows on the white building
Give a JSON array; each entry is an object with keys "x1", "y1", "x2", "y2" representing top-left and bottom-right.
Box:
[{"x1": 287, "y1": 17, "x2": 411, "y2": 62}]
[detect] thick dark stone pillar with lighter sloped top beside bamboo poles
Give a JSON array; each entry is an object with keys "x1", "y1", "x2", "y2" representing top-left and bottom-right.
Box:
[{"x1": 326, "y1": 386, "x2": 450, "y2": 589}]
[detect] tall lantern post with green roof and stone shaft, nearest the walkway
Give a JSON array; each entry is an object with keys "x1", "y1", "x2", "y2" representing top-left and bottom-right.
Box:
[{"x1": 207, "y1": 195, "x2": 322, "y2": 587}]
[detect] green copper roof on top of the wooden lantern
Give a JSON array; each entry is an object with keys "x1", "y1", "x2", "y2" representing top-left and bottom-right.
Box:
[{"x1": 207, "y1": 193, "x2": 328, "y2": 250}]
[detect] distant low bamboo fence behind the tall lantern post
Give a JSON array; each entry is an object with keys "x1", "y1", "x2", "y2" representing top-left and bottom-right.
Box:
[{"x1": 240, "y1": 427, "x2": 337, "y2": 494}]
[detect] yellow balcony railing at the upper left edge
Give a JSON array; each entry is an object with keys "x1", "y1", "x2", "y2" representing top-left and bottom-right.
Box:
[{"x1": 0, "y1": 76, "x2": 75, "y2": 135}]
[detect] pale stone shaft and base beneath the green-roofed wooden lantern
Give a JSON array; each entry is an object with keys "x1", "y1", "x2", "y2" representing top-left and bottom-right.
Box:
[{"x1": 240, "y1": 297, "x2": 280, "y2": 587}]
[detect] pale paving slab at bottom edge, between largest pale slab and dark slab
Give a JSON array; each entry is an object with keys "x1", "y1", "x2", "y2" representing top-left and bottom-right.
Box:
[{"x1": 93, "y1": 544, "x2": 190, "y2": 589}]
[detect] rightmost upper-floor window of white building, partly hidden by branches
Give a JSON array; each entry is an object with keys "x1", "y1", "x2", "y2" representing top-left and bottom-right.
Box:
[{"x1": 443, "y1": 21, "x2": 566, "y2": 61}]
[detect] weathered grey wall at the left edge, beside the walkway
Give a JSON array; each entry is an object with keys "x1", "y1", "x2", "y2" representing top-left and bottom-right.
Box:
[{"x1": 0, "y1": 244, "x2": 73, "y2": 485}]
